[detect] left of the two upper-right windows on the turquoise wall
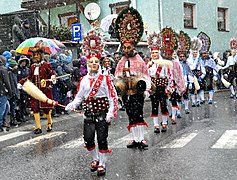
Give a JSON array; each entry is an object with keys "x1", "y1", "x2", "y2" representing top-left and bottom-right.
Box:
[{"x1": 184, "y1": 3, "x2": 195, "y2": 28}]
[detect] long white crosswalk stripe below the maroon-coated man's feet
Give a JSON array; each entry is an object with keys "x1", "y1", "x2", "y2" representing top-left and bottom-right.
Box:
[{"x1": 9, "y1": 131, "x2": 67, "y2": 148}]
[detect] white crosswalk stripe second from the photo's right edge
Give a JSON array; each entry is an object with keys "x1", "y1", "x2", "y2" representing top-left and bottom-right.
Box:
[{"x1": 161, "y1": 133, "x2": 198, "y2": 148}]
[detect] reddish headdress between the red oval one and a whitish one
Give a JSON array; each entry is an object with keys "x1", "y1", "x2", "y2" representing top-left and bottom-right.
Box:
[{"x1": 177, "y1": 31, "x2": 191, "y2": 55}]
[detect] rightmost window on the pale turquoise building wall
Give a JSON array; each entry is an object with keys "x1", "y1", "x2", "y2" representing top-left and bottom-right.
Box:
[{"x1": 217, "y1": 8, "x2": 227, "y2": 31}]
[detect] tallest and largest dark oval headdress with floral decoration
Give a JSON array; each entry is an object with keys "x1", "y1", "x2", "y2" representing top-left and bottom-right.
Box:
[{"x1": 116, "y1": 7, "x2": 144, "y2": 45}]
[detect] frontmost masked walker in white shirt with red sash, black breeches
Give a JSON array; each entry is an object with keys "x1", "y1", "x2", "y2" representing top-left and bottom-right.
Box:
[{"x1": 65, "y1": 31, "x2": 118, "y2": 176}]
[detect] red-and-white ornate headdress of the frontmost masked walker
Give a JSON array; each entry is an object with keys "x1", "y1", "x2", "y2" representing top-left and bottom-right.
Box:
[{"x1": 82, "y1": 30, "x2": 104, "y2": 59}]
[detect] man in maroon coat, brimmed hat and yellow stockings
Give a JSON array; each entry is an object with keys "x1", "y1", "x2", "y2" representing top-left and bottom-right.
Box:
[{"x1": 18, "y1": 41, "x2": 55, "y2": 134}]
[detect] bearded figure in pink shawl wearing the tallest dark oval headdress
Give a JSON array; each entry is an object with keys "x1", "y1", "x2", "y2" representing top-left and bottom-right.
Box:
[{"x1": 114, "y1": 8, "x2": 151, "y2": 148}]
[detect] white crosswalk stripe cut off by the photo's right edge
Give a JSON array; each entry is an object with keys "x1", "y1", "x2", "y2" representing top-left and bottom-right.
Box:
[{"x1": 211, "y1": 130, "x2": 237, "y2": 149}]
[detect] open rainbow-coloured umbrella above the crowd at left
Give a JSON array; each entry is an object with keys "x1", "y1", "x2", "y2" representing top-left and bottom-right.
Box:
[{"x1": 16, "y1": 37, "x2": 60, "y2": 54}]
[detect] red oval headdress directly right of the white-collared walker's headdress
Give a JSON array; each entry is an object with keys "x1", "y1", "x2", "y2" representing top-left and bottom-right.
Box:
[{"x1": 160, "y1": 27, "x2": 178, "y2": 59}]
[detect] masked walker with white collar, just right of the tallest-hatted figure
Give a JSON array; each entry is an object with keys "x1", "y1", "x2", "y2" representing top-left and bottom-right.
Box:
[{"x1": 147, "y1": 29, "x2": 176, "y2": 133}]
